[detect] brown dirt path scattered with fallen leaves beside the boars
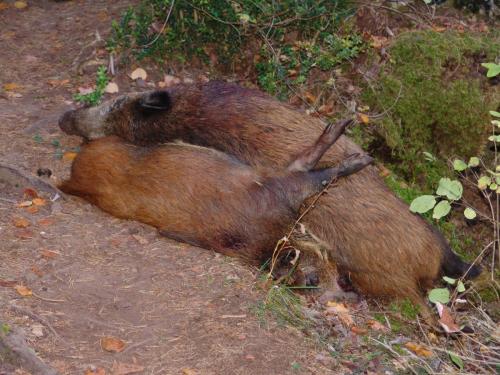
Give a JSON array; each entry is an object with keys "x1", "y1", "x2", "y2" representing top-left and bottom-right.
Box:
[{"x1": 0, "y1": 0, "x2": 336, "y2": 374}]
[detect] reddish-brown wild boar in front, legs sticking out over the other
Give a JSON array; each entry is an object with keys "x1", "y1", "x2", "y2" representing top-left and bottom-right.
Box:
[{"x1": 60, "y1": 121, "x2": 372, "y2": 264}]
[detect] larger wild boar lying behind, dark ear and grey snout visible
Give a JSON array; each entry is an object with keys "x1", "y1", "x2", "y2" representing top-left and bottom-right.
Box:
[{"x1": 60, "y1": 82, "x2": 480, "y2": 312}]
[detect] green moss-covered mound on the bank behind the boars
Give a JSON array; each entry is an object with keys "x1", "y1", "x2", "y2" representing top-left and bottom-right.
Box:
[{"x1": 363, "y1": 31, "x2": 500, "y2": 188}]
